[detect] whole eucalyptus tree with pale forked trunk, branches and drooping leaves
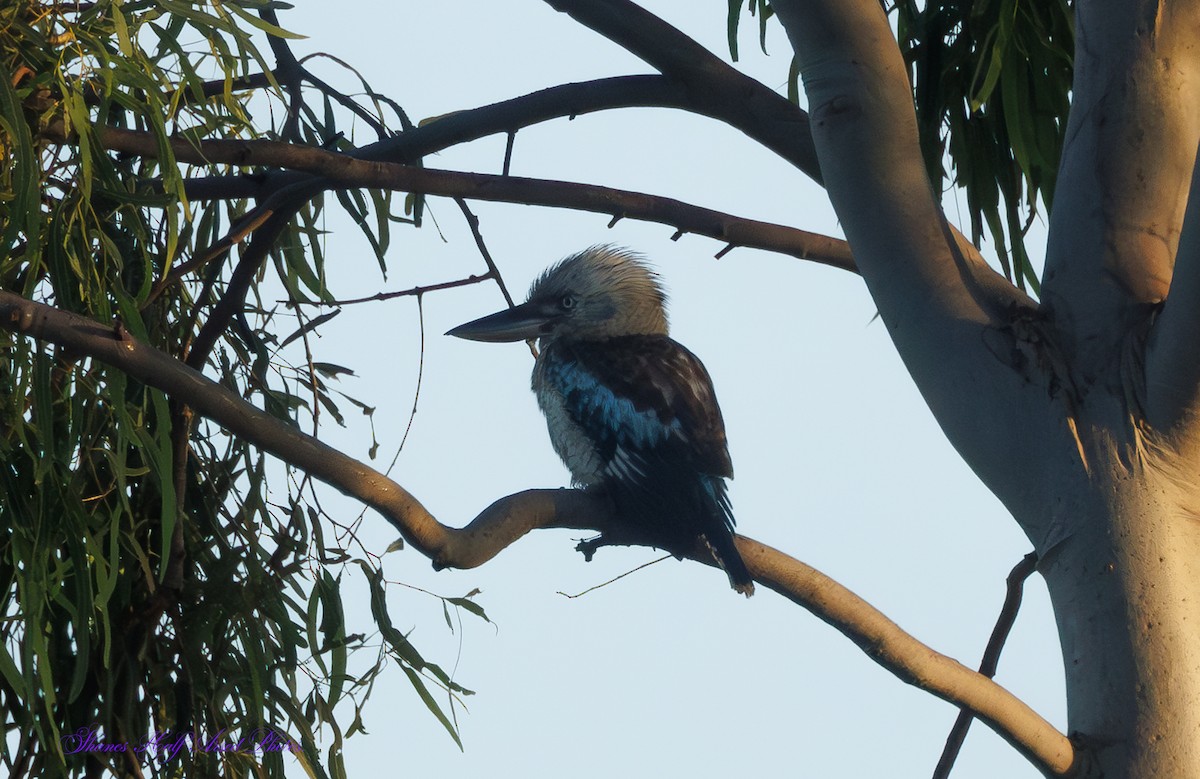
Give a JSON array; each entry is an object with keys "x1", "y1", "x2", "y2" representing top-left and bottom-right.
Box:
[{"x1": 0, "y1": 0, "x2": 1200, "y2": 778}]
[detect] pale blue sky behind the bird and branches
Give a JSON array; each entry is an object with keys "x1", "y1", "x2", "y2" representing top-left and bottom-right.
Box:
[{"x1": 267, "y1": 0, "x2": 1064, "y2": 778}]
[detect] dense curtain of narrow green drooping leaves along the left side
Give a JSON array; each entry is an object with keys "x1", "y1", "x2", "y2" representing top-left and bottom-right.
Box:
[{"x1": 0, "y1": 0, "x2": 481, "y2": 777}]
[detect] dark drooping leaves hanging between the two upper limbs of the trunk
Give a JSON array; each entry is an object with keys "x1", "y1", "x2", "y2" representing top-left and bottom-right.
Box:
[{"x1": 728, "y1": 0, "x2": 1074, "y2": 293}]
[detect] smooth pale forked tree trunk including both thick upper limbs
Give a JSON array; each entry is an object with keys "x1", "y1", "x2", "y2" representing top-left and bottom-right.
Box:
[{"x1": 773, "y1": 0, "x2": 1200, "y2": 779}]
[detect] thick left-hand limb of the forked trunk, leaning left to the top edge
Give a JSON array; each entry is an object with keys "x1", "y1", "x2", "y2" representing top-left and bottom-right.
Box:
[{"x1": 772, "y1": 0, "x2": 1068, "y2": 525}]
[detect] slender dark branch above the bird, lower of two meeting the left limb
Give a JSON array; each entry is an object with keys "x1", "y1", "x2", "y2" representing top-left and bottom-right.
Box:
[{"x1": 49, "y1": 127, "x2": 854, "y2": 270}]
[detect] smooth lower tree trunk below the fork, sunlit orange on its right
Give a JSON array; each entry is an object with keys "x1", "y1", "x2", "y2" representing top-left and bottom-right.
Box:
[{"x1": 1039, "y1": 415, "x2": 1200, "y2": 779}]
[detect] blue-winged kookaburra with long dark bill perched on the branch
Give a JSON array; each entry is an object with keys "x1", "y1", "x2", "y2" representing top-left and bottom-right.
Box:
[{"x1": 446, "y1": 246, "x2": 754, "y2": 595}]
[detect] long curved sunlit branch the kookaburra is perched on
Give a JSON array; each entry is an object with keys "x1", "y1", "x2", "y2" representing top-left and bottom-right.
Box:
[{"x1": 0, "y1": 292, "x2": 1074, "y2": 777}]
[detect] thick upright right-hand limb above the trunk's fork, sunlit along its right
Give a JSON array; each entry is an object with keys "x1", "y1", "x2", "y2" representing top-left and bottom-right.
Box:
[{"x1": 1042, "y1": 0, "x2": 1200, "y2": 378}]
